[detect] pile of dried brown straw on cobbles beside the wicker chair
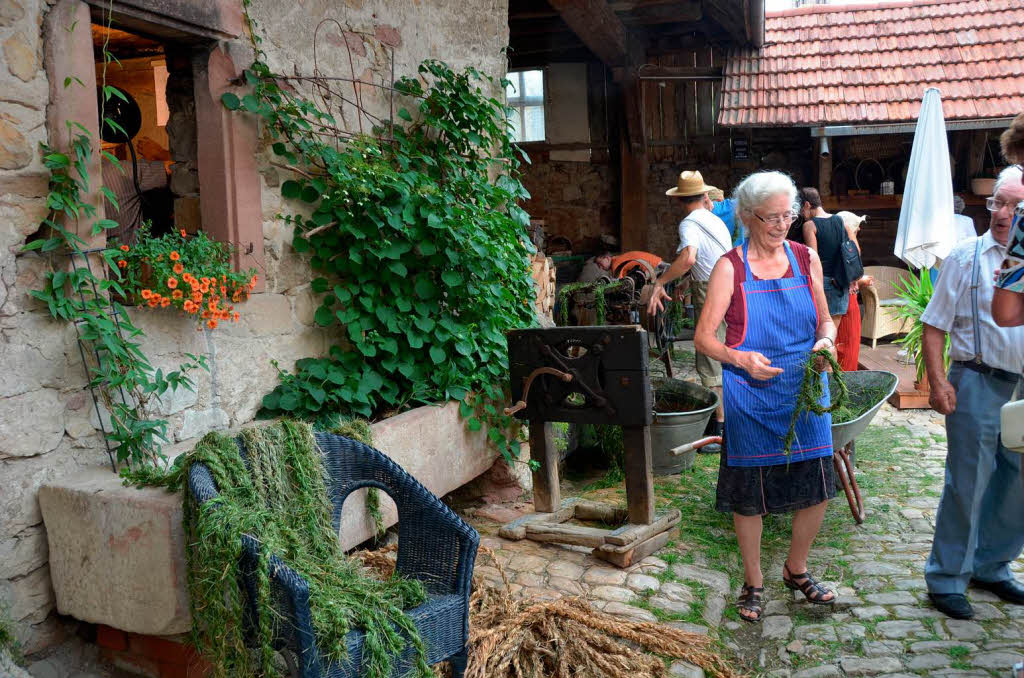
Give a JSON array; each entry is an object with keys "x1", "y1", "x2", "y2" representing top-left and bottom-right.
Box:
[{"x1": 356, "y1": 547, "x2": 739, "y2": 678}]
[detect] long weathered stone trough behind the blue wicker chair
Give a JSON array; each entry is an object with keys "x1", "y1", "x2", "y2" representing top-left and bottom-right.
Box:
[{"x1": 41, "y1": 402, "x2": 497, "y2": 635}]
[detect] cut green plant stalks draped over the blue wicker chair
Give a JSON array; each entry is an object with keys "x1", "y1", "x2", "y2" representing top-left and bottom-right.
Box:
[{"x1": 128, "y1": 420, "x2": 434, "y2": 678}]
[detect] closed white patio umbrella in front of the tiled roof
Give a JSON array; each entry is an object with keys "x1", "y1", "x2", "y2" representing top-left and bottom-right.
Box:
[{"x1": 893, "y1": 87, "x2": 956, "y2": 268}]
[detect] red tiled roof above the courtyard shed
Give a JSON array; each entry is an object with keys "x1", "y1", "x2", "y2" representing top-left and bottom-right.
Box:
[{"x1": 719, "y1": 0, "x2": 1024, "y2": 127}]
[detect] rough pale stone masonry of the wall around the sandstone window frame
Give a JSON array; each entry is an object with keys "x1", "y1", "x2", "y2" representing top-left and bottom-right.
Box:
[{"x1": 0, "y1": 0, "x2": 508, "y2": 652}]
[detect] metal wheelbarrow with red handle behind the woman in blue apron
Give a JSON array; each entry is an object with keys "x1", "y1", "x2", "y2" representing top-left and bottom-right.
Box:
[{"x1": 668, "y1": 370, "x2": 899, "y2": 525}]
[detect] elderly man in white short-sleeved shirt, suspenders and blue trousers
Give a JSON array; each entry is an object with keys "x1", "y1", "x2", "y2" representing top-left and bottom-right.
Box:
[{"x1": 921, "y1": 167, "x2": 1024, "y2": 619}]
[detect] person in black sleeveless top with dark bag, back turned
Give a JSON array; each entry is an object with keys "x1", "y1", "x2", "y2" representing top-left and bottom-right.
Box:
[{"x1": 800, "y1": 186, "x2": 864, "y2": 328}]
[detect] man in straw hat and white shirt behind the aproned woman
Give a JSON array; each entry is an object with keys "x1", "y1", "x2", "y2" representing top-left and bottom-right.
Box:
[{"x1": 647, "y1": 170, "x2": 732, "y2": 453}]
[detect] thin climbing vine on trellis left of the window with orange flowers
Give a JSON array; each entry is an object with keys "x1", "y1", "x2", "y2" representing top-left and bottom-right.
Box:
[{"x1": 23, "y1": 9, "x2": 206, "y2": 466}]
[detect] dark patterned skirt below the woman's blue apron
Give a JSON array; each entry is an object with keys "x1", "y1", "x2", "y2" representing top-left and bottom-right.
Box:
[{"x1": 715, "y1": 438, "x2": 836, "y2": 515}]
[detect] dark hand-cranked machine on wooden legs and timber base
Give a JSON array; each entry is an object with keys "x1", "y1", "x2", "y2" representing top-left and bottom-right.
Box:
[{"x1": 499, "y1": 326, "x2": 680, "y2": 567}]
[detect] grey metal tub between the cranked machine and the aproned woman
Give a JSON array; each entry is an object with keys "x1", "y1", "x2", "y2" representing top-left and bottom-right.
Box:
[{"x1": 650, "y1": 377, "x2": 719, "y2": 475}]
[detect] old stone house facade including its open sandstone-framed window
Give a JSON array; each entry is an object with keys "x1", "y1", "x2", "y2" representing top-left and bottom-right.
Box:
[{"x1": 0, "y1": 0, "x2": 508, "y2": 652}]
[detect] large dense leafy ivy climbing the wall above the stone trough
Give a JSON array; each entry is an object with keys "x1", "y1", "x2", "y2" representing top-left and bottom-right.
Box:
[{"x1": 230, "y1": 51, "x2": 536, "y2": 458}]
